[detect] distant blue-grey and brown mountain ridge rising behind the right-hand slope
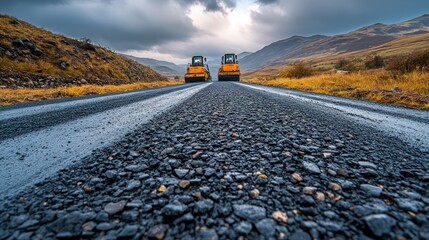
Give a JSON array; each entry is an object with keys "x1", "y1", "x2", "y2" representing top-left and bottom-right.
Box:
[{"x1": 240, "y1": 14, "x2": 429, "y2": 69}]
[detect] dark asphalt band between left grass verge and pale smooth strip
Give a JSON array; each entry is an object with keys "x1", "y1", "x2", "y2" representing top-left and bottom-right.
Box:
[{"x1": 0, "y1": 82, "x2": 197, "y2": 141}]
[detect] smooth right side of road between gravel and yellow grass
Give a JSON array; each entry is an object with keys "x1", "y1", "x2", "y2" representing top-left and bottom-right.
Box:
[{"x1": 239, "y1": 84, "x2": 429, "y2": 152}]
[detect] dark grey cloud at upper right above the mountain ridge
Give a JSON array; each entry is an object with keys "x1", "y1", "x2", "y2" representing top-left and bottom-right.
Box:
[{"x1": 252, "y1": 0, "x2": 429, "y2": 41}]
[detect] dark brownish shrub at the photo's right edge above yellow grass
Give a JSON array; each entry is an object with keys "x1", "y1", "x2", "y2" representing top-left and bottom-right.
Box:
[{"x1": 386, "y1": 50, "x2": 429, "y2": 74}]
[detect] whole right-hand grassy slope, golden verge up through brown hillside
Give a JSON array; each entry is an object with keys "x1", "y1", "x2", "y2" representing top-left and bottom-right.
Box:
[{"x1": 243, "y1": 33, "x2": 429, "y2": 109}]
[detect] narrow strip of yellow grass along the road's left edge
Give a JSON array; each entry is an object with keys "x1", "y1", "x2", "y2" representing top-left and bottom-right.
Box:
[{"x1": 0, "y1": 81, "x2": 183, "y2": 106}]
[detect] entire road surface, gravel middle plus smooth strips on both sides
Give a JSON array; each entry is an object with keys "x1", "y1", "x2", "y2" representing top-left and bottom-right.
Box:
[{"x1": 0, "y1": 82, "x2": 429, "y2": 239}]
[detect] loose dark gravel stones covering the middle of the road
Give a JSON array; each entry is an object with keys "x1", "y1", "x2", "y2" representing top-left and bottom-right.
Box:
[{"x1": 0, "y1": 83, "x2": 429, "y2": 239}]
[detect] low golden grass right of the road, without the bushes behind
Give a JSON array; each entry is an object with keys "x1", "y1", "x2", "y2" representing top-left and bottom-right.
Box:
[{"x1": 244, "y1": 70, "x2": 429, "y2": 109}]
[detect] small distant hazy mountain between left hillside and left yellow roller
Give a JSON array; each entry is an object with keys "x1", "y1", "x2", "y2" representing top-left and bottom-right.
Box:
[{"x1": 124, "y1": 55, "x2": 186, "y2": 77}]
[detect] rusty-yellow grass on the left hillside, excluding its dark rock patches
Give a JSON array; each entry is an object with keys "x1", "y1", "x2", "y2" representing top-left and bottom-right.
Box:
[{"x1": 0, "y1": 14, "x2": 167, "y2": 84}]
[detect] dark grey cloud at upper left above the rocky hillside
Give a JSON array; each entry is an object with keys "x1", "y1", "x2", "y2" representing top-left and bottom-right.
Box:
[{"x1": 0, "y1": 0, "x2": 197, "y2": 51}]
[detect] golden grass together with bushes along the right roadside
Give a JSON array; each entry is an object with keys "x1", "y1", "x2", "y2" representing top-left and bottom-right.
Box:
[{"x1": 243, "y1": 50, "x2": 429, "y2": 109}]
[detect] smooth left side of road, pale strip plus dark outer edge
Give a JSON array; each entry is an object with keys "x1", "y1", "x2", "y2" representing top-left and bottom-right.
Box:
[{"x1": 0, "y1": 84, "x2": 207, "y2": 197}]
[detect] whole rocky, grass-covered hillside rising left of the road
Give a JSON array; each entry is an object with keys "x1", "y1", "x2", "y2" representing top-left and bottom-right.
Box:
[{"x1": 0, "y1": 15, "x2": 167, "y2": 88}]
